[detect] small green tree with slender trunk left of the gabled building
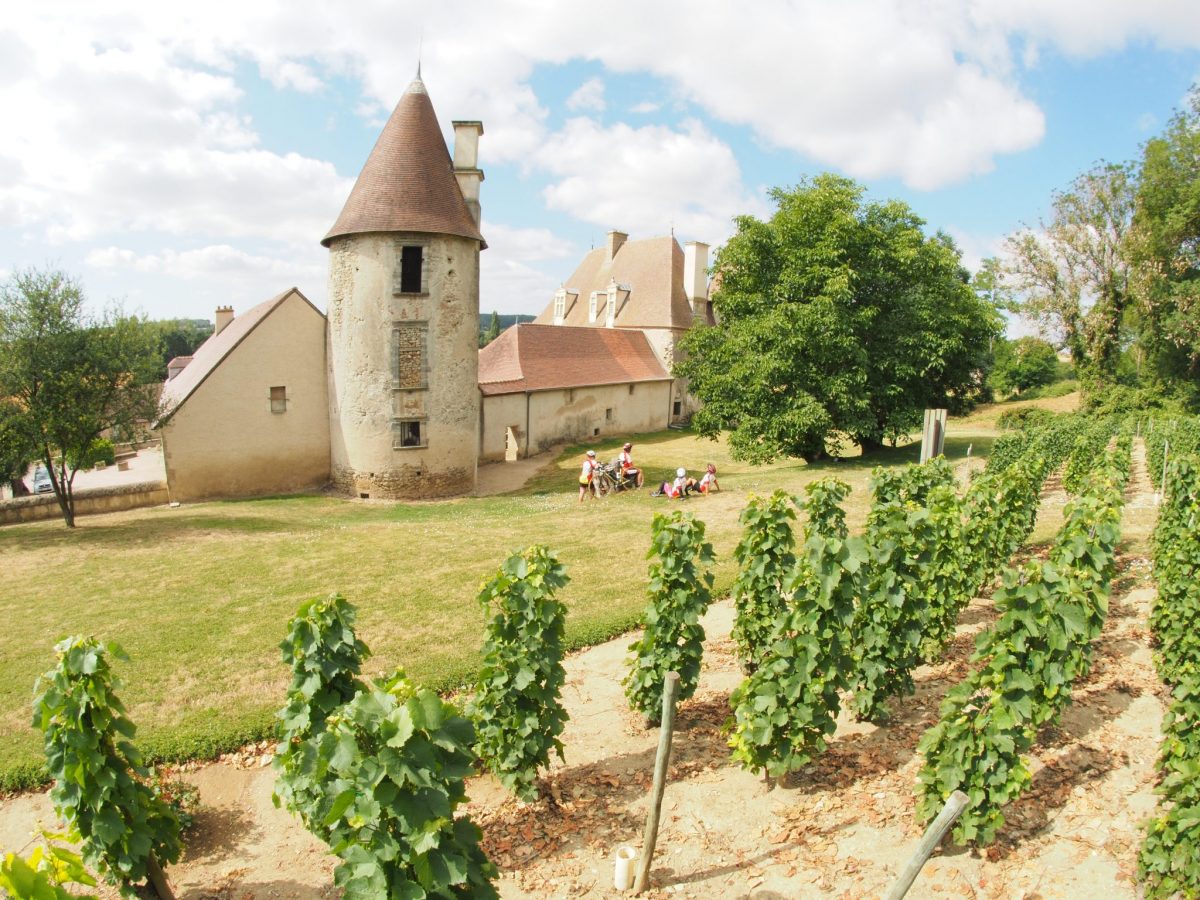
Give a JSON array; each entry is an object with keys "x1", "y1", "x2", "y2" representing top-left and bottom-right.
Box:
[{"x1": 0, "y1": 269, "x2": 157, "y2": 527}]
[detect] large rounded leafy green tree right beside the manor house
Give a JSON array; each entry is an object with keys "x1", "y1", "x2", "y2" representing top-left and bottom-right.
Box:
[{"x1": 676, "y1": 174, "x2": 1000, "y2": 462}]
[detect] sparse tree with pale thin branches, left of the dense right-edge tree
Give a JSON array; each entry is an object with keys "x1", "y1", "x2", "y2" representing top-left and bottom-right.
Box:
[{"x1": 1006, "y1": 163, "x2": 1135, "y2": 397}]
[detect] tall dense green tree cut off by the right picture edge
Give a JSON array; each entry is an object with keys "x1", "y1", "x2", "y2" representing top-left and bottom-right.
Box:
[{"x1": 1129, "y1": 86, "x2": 1200, "y2": 406}]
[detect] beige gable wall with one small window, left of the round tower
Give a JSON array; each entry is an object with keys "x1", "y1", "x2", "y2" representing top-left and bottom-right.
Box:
[{"x1": 162, "y1": 294, "x2": 329, "y2": 500}]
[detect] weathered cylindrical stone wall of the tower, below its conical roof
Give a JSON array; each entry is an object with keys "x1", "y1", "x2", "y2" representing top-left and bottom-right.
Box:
[{"x1": 326, "y1": 233, "x2": 480, "y2": 499}]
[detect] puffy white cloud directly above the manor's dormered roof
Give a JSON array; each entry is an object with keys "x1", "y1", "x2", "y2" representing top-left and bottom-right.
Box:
[{"x1": 538, "y1": 119, "x2": 766, "y2": 244}]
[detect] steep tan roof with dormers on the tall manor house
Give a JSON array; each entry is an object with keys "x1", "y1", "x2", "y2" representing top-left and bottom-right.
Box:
[{"x1": 535, "y1": 235, "x2": 712, "y2": 329}]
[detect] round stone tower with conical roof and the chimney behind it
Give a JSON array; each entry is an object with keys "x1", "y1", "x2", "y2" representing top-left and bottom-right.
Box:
[{"x1": 322, "y1": 71, "x2": 487, "y2": 498}]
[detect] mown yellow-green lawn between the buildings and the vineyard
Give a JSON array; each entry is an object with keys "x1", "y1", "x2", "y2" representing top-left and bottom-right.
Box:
[{"x1": 0, "y1": 398, "x2": 1063, "y2": 790}]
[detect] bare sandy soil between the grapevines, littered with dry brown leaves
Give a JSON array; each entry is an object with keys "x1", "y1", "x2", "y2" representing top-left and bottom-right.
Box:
[{"x1": 0, "y1": 444, "x2": 1163, "y2": 900}]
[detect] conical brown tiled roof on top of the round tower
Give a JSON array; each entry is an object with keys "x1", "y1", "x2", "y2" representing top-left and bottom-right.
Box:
[{"x1": 320, "y1": 74, "x2": 486, "y2": 247}]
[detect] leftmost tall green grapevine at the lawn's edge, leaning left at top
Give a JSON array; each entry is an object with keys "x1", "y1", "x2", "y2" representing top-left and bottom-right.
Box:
[{"x1": 34, "y1": 637, "x2": 182, "y2": 893}]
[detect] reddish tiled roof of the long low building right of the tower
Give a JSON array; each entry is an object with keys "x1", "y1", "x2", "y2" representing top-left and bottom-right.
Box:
[{"x1": 475, "y1": 323, "x2": 671, "y2": 397}]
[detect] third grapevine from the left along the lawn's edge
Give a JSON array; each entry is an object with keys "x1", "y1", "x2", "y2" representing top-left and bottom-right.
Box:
[{"x1": 468, "y1": 545, "x2": 570, "y2": 800}]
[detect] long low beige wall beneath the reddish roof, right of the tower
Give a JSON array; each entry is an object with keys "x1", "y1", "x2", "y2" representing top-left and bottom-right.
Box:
[{"x1": 480, "y1": 382, "x2": 671, "y2": 461}]
